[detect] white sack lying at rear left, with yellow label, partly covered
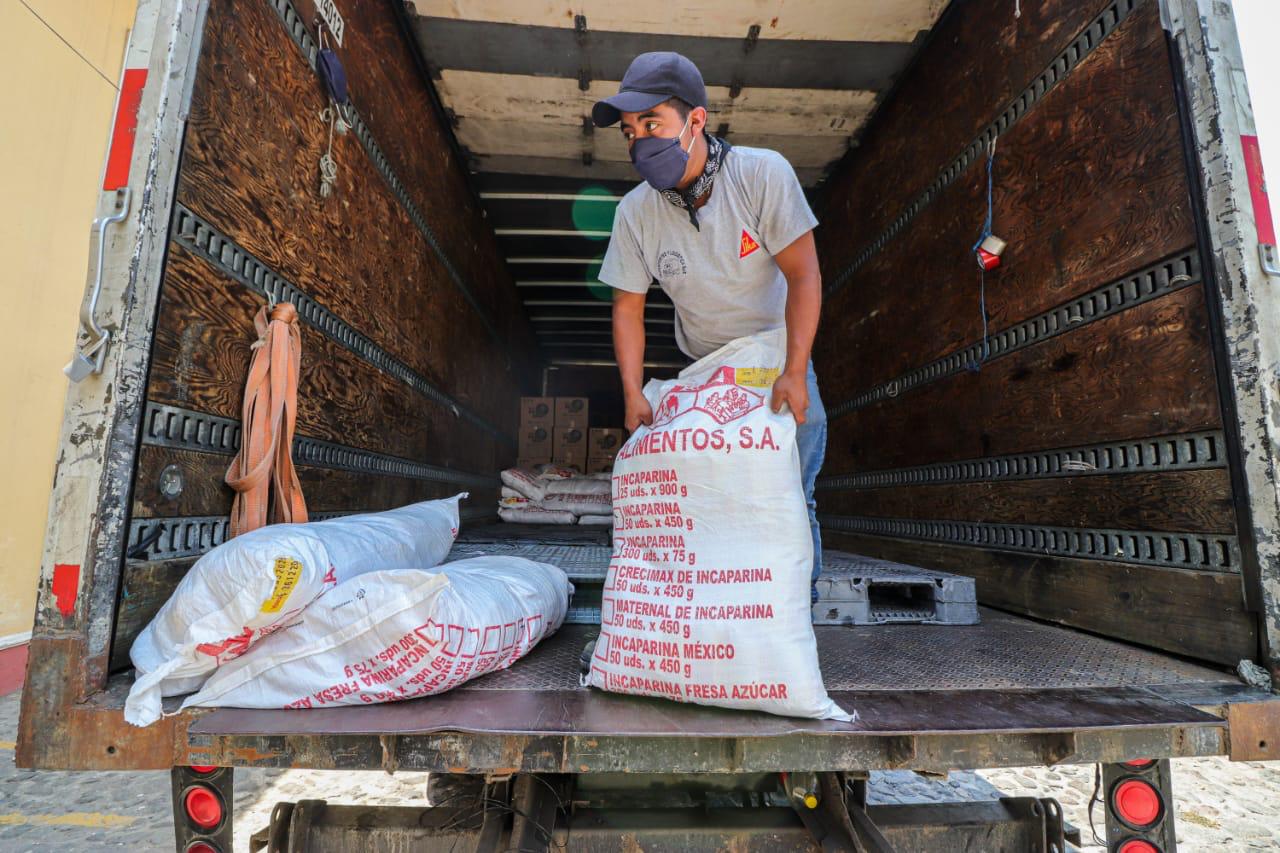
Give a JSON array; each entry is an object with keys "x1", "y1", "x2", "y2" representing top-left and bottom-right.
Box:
[{"x1": 124, "y1": 493, "x2": 466, "y2": 726}]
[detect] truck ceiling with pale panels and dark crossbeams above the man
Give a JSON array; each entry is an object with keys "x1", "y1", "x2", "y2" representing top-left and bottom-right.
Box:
[{"x1": 406, "y1": 0, "x2": 947, "y2": 366}]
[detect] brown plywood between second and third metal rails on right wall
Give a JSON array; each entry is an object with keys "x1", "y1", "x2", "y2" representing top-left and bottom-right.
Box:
[{"x1": 819, "y1": 287, "x2": 1221, "y2": 473}]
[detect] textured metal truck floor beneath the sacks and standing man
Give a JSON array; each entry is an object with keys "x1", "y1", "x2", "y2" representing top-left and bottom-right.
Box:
[{"x1": 192, "y1": 524, "x2": 1238, "y2": 738}]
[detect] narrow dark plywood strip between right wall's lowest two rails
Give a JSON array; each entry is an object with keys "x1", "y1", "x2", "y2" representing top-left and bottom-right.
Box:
[{"x1": 818, "y1": 469, "x2": 1235, "y2": 535}]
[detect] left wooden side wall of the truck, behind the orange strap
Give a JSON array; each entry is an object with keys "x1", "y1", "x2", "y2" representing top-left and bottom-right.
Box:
[{"x1": 111, "y1": 0, "x2": 536, "y2": 666}]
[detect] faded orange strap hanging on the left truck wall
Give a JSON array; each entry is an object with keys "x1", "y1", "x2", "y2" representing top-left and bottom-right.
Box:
[{"x1": 227, "y1": 302, "x2": 307, "y2": 537}]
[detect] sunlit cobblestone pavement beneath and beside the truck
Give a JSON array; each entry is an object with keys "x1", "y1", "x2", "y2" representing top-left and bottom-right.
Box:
[{"x1": 0, "y1": 693, "x2": 1280, "y2": 853}]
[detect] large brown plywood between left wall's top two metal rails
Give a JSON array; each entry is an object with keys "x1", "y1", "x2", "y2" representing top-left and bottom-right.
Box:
[{"x1": 178, "y1": 4, "x2": 516, "y2": 432}]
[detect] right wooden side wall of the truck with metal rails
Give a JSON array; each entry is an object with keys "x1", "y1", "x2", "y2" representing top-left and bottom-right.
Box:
[{"x1": 814, "y1": 0, "x2": 1257, "y2": 665}]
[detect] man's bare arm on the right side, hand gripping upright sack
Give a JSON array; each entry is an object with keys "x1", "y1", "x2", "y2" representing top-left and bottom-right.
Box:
[{"x1": 768, "y1": 231, "x2": 822, "y2": 424}]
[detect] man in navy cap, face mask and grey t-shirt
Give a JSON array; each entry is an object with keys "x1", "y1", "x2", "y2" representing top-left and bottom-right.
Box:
[{"x1": 591, "y1": 53, "x2": 827, "y2": 596}]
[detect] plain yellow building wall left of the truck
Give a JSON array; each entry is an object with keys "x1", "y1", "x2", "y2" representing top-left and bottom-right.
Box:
[{"x1": 0, "y1": 0, "x2": 136, "y2": 638}]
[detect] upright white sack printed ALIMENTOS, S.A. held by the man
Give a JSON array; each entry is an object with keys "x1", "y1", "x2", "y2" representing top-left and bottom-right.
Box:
[{"x1": 585, "y1": 329, "x2": 856, "y2": 722}]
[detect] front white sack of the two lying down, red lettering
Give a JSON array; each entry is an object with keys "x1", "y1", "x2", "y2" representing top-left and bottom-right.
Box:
[{"x1": 183, "y1": 556, "x2": 573, "y2": 708}]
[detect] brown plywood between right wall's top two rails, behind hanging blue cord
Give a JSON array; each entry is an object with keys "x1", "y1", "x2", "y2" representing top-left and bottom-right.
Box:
[{"x1": 819, "y1": 2, "x2": 1196, "y2": 396}]
